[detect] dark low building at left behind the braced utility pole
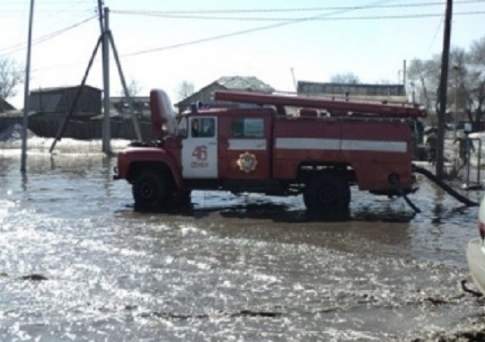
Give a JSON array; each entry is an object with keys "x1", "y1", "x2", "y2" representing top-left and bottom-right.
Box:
[{"x1": 30, "y1": 86, "x2": 101, "y2": 116}]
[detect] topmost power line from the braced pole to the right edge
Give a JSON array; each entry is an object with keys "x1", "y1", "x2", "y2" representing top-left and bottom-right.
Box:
[{"x1": 112, "y1": 0, "x2": 485, "y2": 15}]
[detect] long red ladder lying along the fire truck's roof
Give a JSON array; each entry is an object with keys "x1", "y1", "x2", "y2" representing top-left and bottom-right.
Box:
[{"x1": 214, "y1": 90, "x2": 426, "y2": 119}]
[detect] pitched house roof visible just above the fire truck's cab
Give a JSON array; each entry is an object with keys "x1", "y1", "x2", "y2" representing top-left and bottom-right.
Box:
[{"x1": 175, "y1": 76, "x2": 274, "y2": 113}]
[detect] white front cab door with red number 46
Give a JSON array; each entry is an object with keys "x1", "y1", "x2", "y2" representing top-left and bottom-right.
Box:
[{"x1": 182, "y1": 115, "x2": 218, "y2": 179}]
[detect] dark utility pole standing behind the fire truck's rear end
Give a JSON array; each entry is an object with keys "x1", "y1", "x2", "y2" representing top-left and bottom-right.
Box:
[{"x1": 436, "y1": 0, "x2": 453, "y2": 179}]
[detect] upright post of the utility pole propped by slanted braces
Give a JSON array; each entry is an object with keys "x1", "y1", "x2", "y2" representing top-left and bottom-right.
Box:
[{"x1": 98, "y1": 0, "x2": 111, "y2": 154}]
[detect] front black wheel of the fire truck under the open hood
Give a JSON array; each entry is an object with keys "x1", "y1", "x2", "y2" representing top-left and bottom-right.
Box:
[{"x1": 132, "y1": 168, "x2": 169, "y2": 210}]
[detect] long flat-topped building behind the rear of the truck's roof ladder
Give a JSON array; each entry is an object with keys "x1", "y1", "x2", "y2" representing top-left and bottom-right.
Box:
[{"x1": 297, "y1": 81, "x2": 408, "y2": 102}]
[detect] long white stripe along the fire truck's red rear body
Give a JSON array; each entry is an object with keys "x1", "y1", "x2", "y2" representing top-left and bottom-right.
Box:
[{"x1": 276, "y1": 138, "x2": 407, "y2": 153}]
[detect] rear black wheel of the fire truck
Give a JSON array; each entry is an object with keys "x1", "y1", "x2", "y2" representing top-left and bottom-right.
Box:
[{"x1": 303, "y1": 173, "x2": 350, "y2": 215}]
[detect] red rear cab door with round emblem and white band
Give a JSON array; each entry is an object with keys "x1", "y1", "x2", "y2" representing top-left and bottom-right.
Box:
[{"x1": 219, "y1": 113, "x2": 271, "y2": 180}]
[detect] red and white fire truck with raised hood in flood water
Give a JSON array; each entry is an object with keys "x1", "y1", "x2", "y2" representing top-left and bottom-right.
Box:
[{"x1": 116, "y1": 90, "x2": 425, "y2": 213}]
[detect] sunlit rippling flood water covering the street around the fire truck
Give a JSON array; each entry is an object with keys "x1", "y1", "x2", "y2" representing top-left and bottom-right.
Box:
[{"x1": 0, "y1": 138, "x2": 485, "y2": 341}]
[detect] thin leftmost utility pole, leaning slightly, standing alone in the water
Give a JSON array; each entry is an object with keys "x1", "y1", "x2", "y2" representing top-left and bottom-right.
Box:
[{"x1": 20, "y1": 0, "x2": 34, "y2": 173}]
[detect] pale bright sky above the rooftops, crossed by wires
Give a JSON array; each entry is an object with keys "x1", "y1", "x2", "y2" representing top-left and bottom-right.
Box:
[{"x1": 0, "y1": 0, "x2": 485, "y2": 108}]
